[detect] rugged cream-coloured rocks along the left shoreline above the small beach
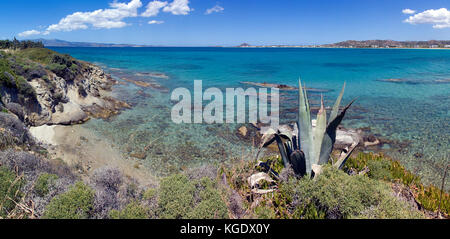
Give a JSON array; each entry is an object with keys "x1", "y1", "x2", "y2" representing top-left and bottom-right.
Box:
[{"x1": 2, "y1": 60, "x2": 130, "y2": 126}]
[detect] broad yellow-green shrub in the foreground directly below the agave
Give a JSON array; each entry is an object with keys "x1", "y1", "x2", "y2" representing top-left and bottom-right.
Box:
[{"x1": 280, "y1": 167, "x2": 422, "y2": 218}]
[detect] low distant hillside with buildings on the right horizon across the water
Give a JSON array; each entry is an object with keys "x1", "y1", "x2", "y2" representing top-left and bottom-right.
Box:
[{"x1": 321, "y1": 40, "x2": 450, "y2": 48}]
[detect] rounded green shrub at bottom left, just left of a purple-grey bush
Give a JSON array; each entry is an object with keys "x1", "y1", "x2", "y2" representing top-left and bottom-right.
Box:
[{"x1": 43, "y1": 182, "x2": 94, "y2": 219}]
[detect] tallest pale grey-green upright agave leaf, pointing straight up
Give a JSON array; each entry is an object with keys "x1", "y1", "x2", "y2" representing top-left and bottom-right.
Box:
[{"x1": 297, "y1": 79, "x2": 313, "y2": 172}]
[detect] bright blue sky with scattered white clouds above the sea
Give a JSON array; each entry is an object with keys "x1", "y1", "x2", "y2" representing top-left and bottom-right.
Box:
[{"x1": 0, "y1": 0, "x2": 450, "y2": 46}]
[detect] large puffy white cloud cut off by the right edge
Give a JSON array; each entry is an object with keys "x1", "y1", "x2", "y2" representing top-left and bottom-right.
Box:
[{"x1": 405, "y1": 8, "x2": 450, "y2": 29}]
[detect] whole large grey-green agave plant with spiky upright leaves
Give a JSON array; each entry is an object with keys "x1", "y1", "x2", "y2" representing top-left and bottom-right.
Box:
[{"x1": 257, "y1": 80, "x2": 356, "y2": 177}]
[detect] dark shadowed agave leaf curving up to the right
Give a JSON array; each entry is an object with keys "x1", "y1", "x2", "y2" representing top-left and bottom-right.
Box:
[{"x1": 319, "y1": 100, "x2": 355, "y2": 165}]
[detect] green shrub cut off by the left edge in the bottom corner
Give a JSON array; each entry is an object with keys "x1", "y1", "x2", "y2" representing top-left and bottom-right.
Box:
[{"x1": 0, "y1": 166, "x2": 25, "y2": 217}]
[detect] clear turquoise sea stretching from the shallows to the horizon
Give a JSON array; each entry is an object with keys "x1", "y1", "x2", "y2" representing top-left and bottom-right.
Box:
[{"x1": 52, "y1": 48, "x2": 450, "y2": 187}]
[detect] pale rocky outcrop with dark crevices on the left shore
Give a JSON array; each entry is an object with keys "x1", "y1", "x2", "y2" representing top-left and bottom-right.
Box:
[{"x1": 0, "y1": 48, "x2": 130, "y2": 126}]
